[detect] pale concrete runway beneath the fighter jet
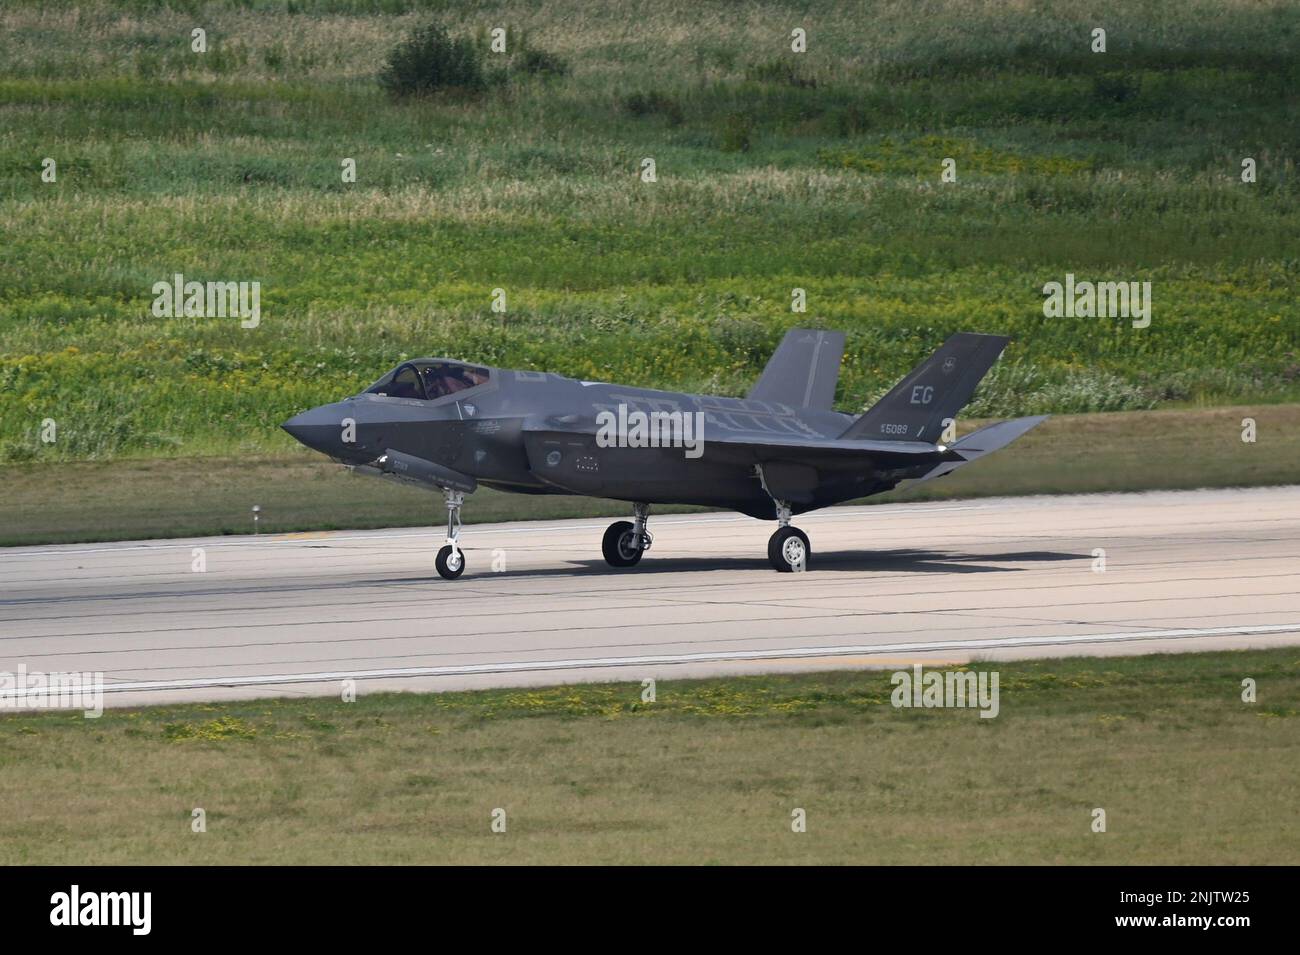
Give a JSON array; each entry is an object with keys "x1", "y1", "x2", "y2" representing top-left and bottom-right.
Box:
[{"x1": 0, "y1": 486, "x2": 1300, "y2": 706}]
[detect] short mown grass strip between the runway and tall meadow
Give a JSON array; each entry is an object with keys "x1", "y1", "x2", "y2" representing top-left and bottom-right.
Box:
[{"x1": 0, "y1": 404, "x2": 1300, "y2": 546}]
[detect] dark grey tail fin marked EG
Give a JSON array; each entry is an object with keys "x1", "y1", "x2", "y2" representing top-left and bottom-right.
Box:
[{"x1": 840, "y1": 331, "x2": 1011, "y2": 442}]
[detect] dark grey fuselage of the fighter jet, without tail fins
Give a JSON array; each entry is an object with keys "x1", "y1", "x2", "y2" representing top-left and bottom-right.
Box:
[{"x1": 285, "y1": 369, "x2": 900, "y2": 518}]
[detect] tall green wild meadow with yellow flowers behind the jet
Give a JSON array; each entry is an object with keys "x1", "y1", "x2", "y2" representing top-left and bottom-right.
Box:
[{"x1": 0, "y1": 0, "x2": 1300, "y2": 464}]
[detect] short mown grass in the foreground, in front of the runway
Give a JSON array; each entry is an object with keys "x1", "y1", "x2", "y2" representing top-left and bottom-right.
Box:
[{"x1": 0, "y1": 647, "x2": 1300, "y2": 865}]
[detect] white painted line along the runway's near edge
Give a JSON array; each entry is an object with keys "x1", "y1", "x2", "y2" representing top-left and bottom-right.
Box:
[{"x1": 0, "y1": 624, "x2": 1300, "y2": 699}]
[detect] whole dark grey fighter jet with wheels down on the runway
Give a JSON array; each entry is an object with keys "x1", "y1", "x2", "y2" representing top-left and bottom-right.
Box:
[{"x1": 282, "y1": 329, "x2": 1045, "y2": 579}]
